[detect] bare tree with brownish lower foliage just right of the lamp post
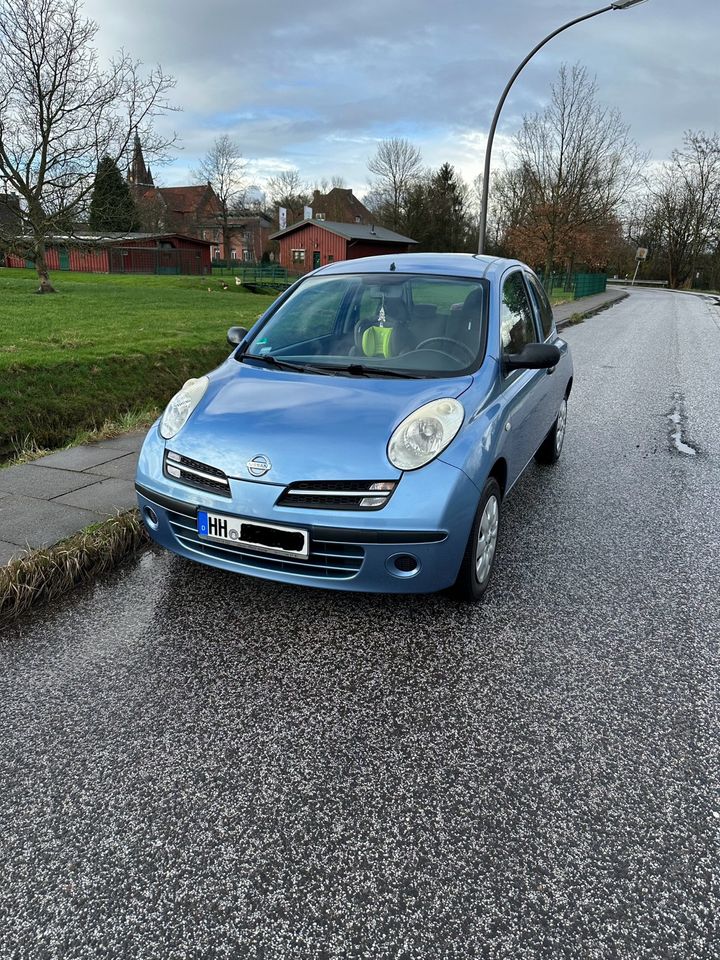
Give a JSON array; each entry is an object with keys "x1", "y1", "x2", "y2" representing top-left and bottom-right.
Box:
[{"x1": 498, "y1": 64, "x2": 647, "y2": 272}]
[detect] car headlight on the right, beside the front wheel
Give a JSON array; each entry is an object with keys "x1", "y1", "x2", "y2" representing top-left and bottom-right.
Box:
[{"x1": 388, "y1": 397, "x2": 465, "y2": 470}]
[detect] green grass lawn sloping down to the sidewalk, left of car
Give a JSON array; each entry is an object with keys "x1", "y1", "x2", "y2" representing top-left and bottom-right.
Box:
[{"x1": 0, "y1": 268, "x2": 274, "y2": 459}]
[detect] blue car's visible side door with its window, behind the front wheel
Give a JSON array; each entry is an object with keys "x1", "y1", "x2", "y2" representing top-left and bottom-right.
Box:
[{"x1": 500, "y1": 267, "x2": 550, "y2": 486}]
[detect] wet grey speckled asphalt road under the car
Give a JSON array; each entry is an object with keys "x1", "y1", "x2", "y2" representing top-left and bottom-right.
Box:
[{"x1": 0, "y1": 291, "x2": 720, "y2": 960}]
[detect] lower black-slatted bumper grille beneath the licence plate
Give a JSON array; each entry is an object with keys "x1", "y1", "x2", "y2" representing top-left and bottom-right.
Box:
[{"x1": 167, "y1": 508, "x2": 365, "y2": 580}]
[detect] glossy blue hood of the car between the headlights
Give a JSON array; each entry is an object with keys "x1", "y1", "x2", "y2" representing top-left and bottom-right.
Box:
[{"x1": 167, "y1": 360, "x2": 473, "y2": 485}]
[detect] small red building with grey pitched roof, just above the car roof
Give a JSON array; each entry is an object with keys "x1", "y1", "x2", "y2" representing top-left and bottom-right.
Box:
[{"x1": 270, "y1": 220, "x2": 417, "y2": 273}]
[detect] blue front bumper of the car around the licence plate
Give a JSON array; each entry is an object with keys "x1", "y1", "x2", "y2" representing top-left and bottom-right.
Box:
[{"x1": 136, "y1": 427, "x2": 480, "y2": 593}]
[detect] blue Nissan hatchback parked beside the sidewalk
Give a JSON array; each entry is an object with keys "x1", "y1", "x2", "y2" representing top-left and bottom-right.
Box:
[{"x1": 136, "y1": 254, "x2": 573, "y2": 600}]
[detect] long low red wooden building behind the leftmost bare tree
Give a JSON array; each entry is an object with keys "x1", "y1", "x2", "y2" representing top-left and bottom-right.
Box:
[{"x1": 6, "y1": 233, "x2": 212, "y2": 276}]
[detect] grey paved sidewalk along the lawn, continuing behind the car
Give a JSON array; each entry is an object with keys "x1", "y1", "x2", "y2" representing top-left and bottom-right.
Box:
[{"x1": 0, "y1": 290, "x2": 625, "y2": 566}]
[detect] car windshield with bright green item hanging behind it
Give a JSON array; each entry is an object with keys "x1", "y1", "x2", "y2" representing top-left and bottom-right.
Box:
[{"x1": 242, "y1": 273, "x2": 487, "y2": 377}]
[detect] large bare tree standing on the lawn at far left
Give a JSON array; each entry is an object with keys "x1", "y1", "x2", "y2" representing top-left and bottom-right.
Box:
[{"x1": 0, "y1": 0, "x2": 175, "y2": 293}]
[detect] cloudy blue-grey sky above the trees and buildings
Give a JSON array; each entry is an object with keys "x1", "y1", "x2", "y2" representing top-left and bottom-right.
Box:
[{"x1": 84, "y1": 0, "x2": 720, "y2": 196}]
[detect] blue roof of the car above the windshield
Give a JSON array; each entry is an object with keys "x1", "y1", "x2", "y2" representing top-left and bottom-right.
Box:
[{"x1": 312, "y1": 253, "x2": 527, "y2": 280}]
